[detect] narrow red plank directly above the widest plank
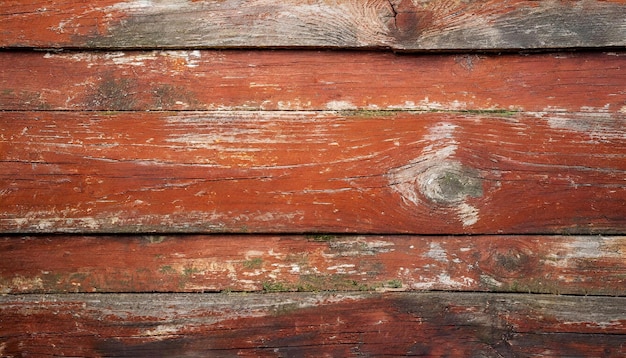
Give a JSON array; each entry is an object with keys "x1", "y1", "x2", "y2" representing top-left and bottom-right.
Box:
[{"x1": 0, "y1": 51, "x2": 626, "y2": 113}]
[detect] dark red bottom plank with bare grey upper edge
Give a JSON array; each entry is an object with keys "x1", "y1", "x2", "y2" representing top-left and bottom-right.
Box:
[{"x1": 0, "y1": 292, "x2": 626, "y2": 357}]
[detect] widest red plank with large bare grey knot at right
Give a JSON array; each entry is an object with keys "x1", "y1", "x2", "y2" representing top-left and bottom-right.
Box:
[{"x1": 0, "y1": 112, "x2": 626, "y2": 234}]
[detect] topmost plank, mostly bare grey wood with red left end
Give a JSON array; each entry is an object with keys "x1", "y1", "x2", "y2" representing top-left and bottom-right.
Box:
[{"x1": 0, "y1": 0, "x2": 626, "y2": 51}]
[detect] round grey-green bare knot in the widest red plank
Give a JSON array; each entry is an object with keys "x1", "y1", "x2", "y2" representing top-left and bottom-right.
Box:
[{"x1": 417, "y1": 162, "x2": 483, "y2": 205}]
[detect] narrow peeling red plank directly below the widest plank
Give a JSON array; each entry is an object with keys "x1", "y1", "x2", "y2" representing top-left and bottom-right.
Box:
[{"x1": 0, "y1": 235, "x2": 626, "y2": 295}]
